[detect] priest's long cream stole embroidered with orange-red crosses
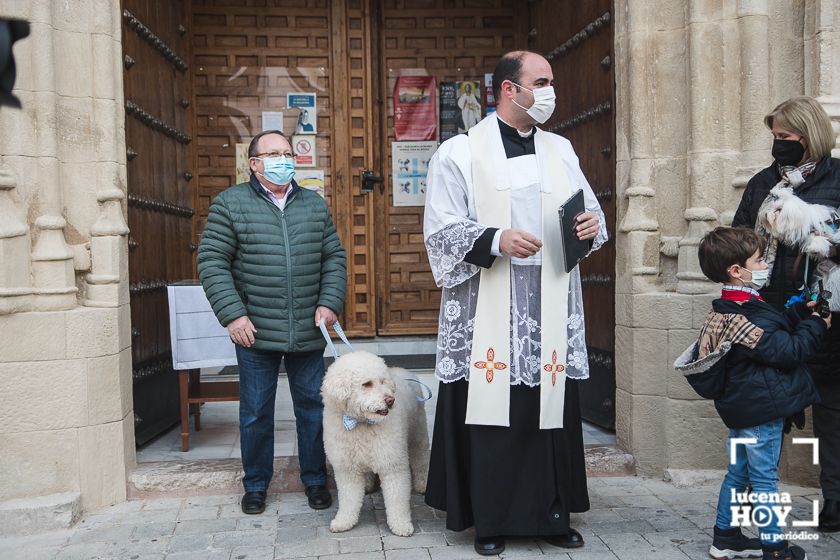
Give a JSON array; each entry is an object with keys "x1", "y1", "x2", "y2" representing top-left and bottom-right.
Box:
[{"x1": 466, "y1": 115, "x2": 572, "y2": 429}]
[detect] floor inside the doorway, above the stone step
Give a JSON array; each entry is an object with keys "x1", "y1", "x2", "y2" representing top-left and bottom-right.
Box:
[{"x1": 137, "y1": 371, "x2": 615, "y2": 463}]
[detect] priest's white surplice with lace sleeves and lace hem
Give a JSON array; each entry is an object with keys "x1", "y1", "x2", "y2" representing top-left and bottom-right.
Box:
[{"x1": 424, "y1": 115, "x2": 607, "y2": 414}]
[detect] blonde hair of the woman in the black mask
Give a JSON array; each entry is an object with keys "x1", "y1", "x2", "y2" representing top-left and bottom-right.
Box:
[{"x1": 764, "y1": 95, "x2": 837, "y2": 161}]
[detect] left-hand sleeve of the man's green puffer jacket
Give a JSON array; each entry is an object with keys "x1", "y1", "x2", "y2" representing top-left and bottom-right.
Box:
[{"x1": 198, "y1": 197, "x2": 248, "y2": 327}]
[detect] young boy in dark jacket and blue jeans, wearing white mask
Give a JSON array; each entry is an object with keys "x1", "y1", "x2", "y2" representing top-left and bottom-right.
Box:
[{"x1": 674, "y1": 227, "x2": 831, "y2": 560}]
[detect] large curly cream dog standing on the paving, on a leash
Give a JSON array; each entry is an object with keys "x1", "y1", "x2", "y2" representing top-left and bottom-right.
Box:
[{"x1": 321, "y1": 351, "x2": 429, "y2": 537}]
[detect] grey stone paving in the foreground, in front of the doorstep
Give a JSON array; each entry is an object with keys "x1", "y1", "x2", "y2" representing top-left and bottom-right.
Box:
[{"x1": 0, "y1": 473, "x2": 840, "y2": 560}]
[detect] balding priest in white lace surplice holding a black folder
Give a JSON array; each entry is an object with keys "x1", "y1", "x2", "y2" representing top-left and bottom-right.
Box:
[{"x1": 424, "y1": 51, "x2": 607, "y2": 555}]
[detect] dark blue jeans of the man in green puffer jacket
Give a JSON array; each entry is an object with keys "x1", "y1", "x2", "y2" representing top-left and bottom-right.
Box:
[{"x1": 236, "y1": 345, "x2": 327, "y2": 492}]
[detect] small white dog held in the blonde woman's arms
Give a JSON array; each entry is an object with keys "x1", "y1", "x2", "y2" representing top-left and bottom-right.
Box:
[{"x1": 758, "y1": 185, "x2": 840, "y2": 311}]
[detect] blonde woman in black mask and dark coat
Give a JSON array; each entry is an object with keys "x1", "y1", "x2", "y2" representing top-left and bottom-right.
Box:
[{"x1": 732, "y1": 97, "x2": 840, "y2": 548}]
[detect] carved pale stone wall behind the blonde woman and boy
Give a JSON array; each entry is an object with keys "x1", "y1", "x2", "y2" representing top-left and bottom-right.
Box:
[{"x1": 615, "y1": 0, "x2": 840, "y2": 484}]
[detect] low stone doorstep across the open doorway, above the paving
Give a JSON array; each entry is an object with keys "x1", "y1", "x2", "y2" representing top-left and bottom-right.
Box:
[{"x1": 128, "y1": 445, "x2": 636, "y2": 499}]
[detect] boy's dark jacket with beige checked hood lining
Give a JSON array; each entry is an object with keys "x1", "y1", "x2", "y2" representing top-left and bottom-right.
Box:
[{"x1": 674, "y1": 297, "x2": 826, "y2": 429}]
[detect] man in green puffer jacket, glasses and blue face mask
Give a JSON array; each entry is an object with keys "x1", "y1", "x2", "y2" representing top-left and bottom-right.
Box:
[{"x1": 198, "y1": 130, "x2": 347, "y2": 514}]
